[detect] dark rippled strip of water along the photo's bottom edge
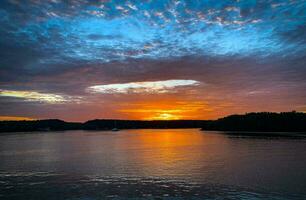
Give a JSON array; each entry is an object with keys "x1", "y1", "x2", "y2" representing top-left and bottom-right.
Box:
[{"x1": 0, "y1": 172, "x2": 306, "y2": 200}]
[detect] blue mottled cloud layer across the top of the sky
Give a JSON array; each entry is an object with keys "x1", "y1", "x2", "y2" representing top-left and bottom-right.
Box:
[{"x1": 0, "y1": 1, "x2": 305, "y2": 67}]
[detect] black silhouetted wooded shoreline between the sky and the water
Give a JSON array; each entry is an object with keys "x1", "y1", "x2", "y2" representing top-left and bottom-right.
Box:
[{"x1": 0, "y1": 111, "x2": 306, "y2": 133}]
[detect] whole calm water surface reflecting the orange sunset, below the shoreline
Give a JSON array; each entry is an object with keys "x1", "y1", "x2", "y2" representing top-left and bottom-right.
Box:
[{"x1": 0, "y1": 129, "x2": 306, "y2": 200}]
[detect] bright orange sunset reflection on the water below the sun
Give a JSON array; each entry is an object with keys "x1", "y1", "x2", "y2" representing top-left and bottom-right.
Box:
[{"x1": 112, "y1": 129, "x2": 230, "y2": 177}]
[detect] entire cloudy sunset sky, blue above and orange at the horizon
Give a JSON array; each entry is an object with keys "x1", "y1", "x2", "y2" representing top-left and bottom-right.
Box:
[{"x1": 0, "y1": 0, "x2": 306, "y2": 121}]
